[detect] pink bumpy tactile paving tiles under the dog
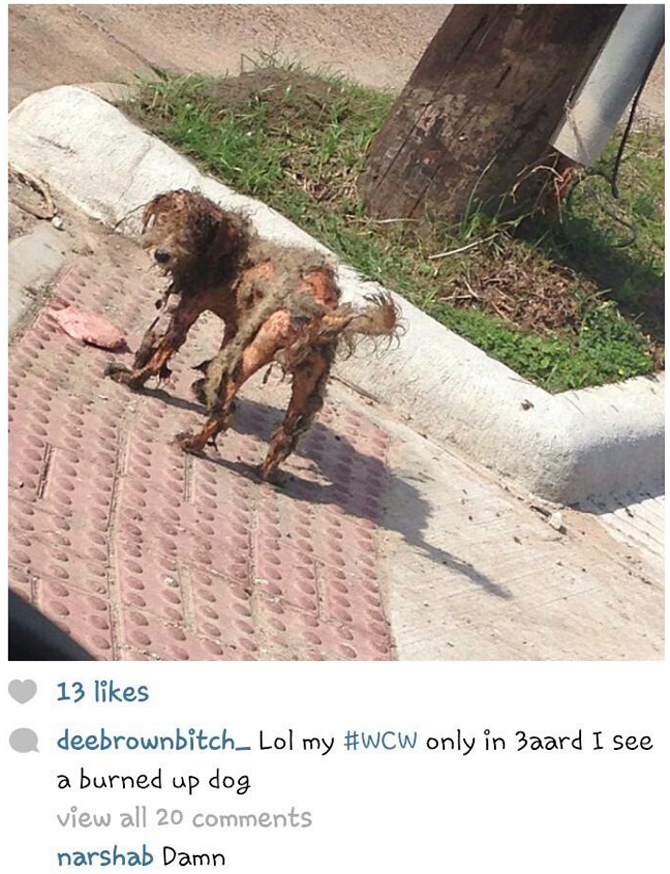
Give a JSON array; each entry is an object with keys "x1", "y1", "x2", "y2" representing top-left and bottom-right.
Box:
[{"x1": 9, "y1": 260, "x2": 393, "y2": 660}]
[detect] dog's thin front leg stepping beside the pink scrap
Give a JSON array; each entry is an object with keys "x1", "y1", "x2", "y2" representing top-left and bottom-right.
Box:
[{"x1": 105, "y1": 295, "x2": 207, "y2": 390}]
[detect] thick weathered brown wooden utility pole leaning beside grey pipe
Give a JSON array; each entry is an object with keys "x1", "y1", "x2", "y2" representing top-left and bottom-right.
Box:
[{"x1": 360, "y1": 4, "x2": 624, "y2": 219}]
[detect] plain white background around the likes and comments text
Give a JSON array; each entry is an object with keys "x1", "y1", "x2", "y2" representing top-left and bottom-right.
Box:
[{"x1": 2, "y1": 662, "x2": 667, "y2": 874}]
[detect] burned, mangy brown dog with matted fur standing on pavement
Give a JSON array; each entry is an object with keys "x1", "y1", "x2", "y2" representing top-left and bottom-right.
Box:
[{"x1": 107, "y1": 189, "x2": 400, "y2": 480}]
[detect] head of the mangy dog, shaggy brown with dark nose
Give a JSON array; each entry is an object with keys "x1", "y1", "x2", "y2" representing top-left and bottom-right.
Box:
[{"x1": 142, "y1": 189, "x2": 249, "y2": 279}]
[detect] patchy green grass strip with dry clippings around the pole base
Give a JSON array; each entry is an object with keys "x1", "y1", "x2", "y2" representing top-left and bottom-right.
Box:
[{"x1": 126, "y1": 63, "x2": 663, "y2": 391}]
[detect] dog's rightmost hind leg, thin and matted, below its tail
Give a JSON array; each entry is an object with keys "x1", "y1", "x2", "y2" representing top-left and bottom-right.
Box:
[{"x1": 259, "y1": 347, "x2": 334, "y2": 481}]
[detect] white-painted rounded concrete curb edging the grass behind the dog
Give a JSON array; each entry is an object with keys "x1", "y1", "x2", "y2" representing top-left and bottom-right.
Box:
[{"x1": 9, "y1": 86, "x2": 664, "y2": 503}]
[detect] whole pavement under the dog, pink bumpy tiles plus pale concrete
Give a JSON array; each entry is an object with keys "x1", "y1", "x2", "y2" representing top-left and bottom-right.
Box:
[{"x1": 10, "y1": 220, "x2": 663, "y2": 659}]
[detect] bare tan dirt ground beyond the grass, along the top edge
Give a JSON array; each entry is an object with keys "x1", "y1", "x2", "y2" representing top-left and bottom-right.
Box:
[{"x1": 9, "y1": 3, "x2": 451, "y2": 106}]
